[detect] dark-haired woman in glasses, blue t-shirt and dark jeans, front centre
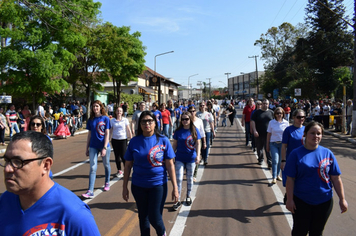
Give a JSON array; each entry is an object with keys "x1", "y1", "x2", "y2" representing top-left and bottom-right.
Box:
[{"x1": 122, "y1": 111, "x2": 179, "y2": 235}]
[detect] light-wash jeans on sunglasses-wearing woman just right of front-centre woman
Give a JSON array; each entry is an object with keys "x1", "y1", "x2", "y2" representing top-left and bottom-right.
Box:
[{"x1": 175, "y1": 160, "x2": 195, "y2": 201}]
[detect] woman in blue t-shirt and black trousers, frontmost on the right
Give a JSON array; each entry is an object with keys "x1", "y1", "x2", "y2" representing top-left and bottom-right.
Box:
[{"x1": 284, "y1": 121, "x2": 348, "y2": 236}]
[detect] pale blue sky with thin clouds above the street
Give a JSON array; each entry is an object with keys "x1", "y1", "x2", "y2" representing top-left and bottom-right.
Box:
[{"x1": 99, "y1": 0, "x2": 354, "y2": 88}]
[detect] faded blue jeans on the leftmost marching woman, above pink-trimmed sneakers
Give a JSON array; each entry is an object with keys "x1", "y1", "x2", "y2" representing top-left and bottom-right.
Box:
[{"x1": 89, "y1": 147, "x2": 111, "y2": 192}]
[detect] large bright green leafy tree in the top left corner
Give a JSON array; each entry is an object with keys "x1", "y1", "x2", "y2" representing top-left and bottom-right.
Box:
[{"x1": 0, "y1": 0, "x2": 100, "y2": 109}]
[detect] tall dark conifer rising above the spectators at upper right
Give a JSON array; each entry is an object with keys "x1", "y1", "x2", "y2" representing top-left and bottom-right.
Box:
[{"x1": 296, "y1": 0, "x2": 353, "y2": 95}]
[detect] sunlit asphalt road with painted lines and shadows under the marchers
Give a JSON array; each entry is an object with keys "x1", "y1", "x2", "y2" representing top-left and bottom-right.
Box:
[{"x1": 0, "y1": 110, "x2": 356, "y2": 236}]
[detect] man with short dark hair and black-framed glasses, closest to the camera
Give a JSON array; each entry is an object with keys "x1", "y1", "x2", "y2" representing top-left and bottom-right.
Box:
[{"x1": 0, "y1": 131, "x2": 100, "y2": 236}]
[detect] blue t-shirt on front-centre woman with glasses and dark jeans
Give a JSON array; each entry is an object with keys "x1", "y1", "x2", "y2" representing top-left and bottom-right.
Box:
[{"x1": 124, "y1": 135, "x2": 175, "y2": 188}]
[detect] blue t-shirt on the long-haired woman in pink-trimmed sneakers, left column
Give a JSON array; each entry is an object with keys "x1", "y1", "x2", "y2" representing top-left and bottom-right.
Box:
[{"x1": 87, "y1": 116, "x2": 111, "y2": 149}]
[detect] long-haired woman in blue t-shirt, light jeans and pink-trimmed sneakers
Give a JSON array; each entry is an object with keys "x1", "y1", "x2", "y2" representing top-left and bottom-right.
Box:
[{"x1": 82, "y1": 100, "x2": 111, "y2": 198}]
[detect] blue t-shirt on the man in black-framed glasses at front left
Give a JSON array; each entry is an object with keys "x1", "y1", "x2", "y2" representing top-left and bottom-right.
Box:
[{"x1": 0, "y1": 183, "x2": 100, "y2": 236}]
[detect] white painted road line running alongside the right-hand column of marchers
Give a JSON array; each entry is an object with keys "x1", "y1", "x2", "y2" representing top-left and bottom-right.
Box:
[{"x1": 235, "y1": 118, "x2": 293, "y2": 228}]
